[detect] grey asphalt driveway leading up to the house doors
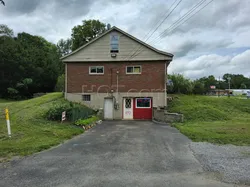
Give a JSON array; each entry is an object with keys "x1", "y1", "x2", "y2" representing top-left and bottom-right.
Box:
[{"x1": 0, "y1": 121, "x2": 243, "y2": 187}]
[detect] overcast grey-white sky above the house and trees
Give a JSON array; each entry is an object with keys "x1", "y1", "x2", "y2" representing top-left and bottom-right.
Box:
[{"x1": 0, "y1": 0, "x2": 250, "y2": 79}]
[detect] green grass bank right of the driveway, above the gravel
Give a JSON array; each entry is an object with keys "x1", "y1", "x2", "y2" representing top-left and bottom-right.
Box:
[{"x1": 170, "y1": 95, "x2": 250, "y2": 145}]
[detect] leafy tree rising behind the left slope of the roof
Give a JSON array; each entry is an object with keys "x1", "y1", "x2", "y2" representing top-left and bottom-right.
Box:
[{"x1": 71, "y1": 20, "x2": 107, "y2": 51}]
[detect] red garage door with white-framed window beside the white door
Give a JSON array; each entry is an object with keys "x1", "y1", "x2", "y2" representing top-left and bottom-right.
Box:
[{"x1": 133, "y1": 97, "x2": 152, "y2": 120}]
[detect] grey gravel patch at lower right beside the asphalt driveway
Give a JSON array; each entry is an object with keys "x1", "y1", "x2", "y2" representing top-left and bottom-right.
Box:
[{"x1": 190, "y1": 142, "x2": 250, "y2": 185}]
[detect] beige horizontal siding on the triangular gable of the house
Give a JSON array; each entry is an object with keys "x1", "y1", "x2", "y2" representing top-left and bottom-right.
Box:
[{"x1": 63, "y1": 31, "x2": 171, "y2": 62}]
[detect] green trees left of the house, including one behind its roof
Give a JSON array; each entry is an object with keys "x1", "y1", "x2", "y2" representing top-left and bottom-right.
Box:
[{"x1": 0, "y1": 20, "x2": 107, "y2": 99}]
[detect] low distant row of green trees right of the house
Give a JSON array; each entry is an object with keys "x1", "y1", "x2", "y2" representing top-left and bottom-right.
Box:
[{"x1": 168, "y1": 73, "x2": 250, "y2": 94}]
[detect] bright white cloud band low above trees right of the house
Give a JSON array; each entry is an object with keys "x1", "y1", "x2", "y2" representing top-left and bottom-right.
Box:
[{"x1": 169, "y1": 50, "x2": 250, "y2": 79}]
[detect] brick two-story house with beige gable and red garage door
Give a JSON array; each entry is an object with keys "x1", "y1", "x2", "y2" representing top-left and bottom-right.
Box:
[{"x1": 62, "y1": 27, "x2": 173, "y2": 120}]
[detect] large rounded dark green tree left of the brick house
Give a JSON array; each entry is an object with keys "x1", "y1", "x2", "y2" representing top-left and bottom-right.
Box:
[{"x1": 17, "y1": 33, "x2": 63, "y2": 93}]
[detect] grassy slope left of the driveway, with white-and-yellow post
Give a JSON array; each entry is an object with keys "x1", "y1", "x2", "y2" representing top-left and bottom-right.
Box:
[{"x1": 0, "y1": 93, "x2": 83, "y2": 160}]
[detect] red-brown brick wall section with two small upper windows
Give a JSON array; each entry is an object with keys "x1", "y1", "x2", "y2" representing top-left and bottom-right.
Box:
[{"x1": 67, "y1": 61, "x2": 169, "y2": 93}]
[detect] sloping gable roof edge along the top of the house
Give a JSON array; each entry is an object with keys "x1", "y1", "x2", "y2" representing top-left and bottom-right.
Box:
[{"x1": 60, "y1": 26, "x2": 174, "y2": 60}]
